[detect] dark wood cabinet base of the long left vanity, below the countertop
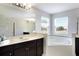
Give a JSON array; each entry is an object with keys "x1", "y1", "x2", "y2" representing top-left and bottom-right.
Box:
[{"x1": 0, "y1": 38, "x2": 44, "y2": 56}]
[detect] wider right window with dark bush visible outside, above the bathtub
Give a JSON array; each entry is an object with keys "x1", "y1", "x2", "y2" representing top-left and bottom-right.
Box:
[{"x1": 54, "y1": 17, "x2": 68, "y2": 35}]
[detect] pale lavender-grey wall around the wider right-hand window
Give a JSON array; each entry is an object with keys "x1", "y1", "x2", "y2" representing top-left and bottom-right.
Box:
[{"x1": 52, "y1": 9, "x2": 79, "y2": 36}]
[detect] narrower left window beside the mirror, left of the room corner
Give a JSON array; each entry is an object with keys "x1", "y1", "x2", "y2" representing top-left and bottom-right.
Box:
[{"x1": 41, "y1": 16, "x2": 49, "y2": 33}]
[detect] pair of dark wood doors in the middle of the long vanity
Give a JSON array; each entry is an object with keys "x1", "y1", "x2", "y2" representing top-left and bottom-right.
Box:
[{"x1": 14, "y1": 40, "x2": 36, "y2": 56}]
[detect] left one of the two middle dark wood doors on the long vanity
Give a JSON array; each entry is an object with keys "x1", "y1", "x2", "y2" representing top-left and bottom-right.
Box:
[{"x1": 14, "y1": 42, "x2": 29, "y2": 56}]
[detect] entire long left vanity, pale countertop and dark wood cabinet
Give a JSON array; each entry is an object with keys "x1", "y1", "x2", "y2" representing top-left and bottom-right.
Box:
[{"x1": 0, "y1": 33, "x2": 46, "y2": 56}]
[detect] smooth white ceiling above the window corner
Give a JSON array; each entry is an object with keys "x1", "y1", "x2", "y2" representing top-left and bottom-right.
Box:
[{"x1": 34, "y1": 3, "x2": 79, "y2": 14}]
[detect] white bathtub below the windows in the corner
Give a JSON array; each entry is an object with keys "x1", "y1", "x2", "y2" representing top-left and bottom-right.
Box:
[{"x1": 47, "y1": 35, "x2": 72, "y2": 46}]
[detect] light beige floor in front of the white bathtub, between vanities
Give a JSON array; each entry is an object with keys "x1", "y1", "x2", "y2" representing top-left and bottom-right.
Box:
[{"x1": 45, "y1": 45, "x2": 73, "y2": 56}]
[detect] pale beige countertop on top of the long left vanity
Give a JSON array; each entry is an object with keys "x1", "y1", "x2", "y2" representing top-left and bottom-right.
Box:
[{"x1": 0, "y1": 33, "x2": 47, "y2": 47}]
